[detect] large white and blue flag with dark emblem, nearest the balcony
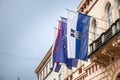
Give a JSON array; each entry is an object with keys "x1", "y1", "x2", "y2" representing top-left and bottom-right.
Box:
[{"x1": 67, "y1": 10, "x2": 91, "y2": 61}]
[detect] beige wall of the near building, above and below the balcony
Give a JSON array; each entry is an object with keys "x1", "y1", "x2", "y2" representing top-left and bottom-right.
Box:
[{"x1": 63, "y1": 0, "x2": 120, "y2": 80}]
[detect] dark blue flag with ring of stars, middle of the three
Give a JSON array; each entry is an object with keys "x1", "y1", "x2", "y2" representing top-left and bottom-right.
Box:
[{"x1": 56, "y1": 17, "x2": 77, "y2": 69}]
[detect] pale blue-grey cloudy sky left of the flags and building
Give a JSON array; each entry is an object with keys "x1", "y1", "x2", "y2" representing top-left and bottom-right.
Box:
[{"x1": 0, "y1": 0, "x2": 81, "y2": 80}]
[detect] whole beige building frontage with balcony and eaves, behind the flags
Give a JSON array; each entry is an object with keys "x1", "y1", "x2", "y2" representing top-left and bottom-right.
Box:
[{"x1": 36, "y1": 0, "x2": 120, "y2": 80}]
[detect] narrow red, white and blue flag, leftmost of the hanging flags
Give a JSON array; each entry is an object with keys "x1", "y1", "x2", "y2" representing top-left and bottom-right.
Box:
[{"x1": 50, "y1": 22, "x2": 61, "y2": 72}]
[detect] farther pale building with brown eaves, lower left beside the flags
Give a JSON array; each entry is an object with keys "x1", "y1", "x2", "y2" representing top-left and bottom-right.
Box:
[{"x1": 35, "y1": 47, "x2": 63, "y2": 80}]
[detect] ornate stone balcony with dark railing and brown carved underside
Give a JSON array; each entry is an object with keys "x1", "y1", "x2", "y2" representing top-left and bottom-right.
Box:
[{"x1": 88, "y1": 19, "x2": 120, "y2": 66}]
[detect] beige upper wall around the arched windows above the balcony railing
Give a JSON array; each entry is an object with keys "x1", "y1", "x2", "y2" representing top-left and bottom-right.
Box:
[{"x1": 88, "y1": 0, "x2": 119, "y2": 44}]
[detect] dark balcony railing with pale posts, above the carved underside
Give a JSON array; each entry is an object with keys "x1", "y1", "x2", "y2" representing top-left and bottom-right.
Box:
[{"x1": 90, "y1": 19, "x2": 120, "y2": 55}]
